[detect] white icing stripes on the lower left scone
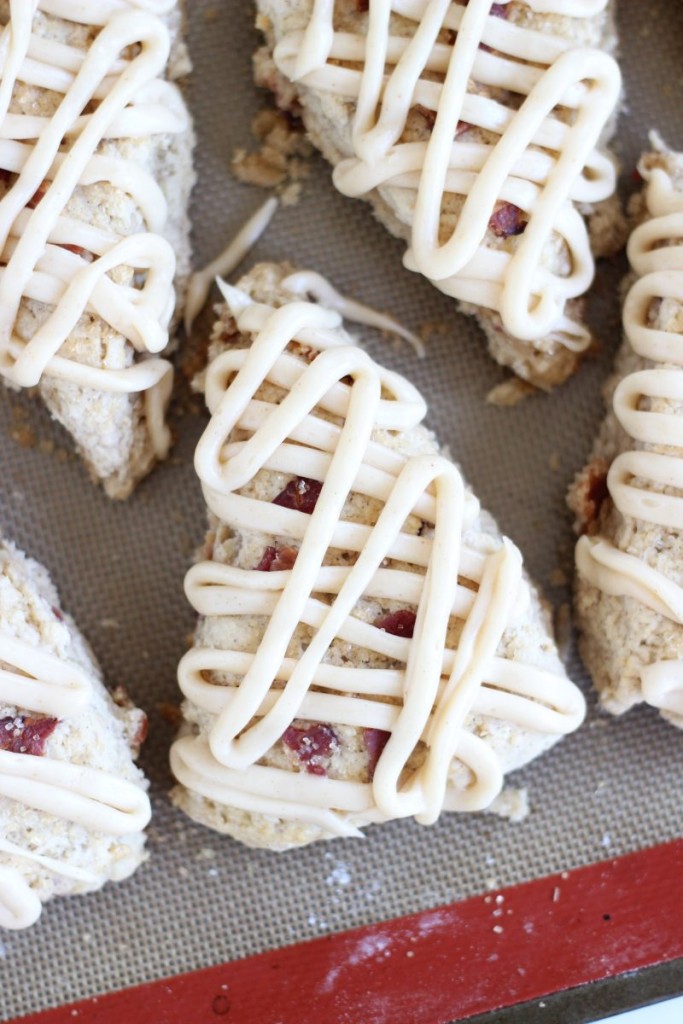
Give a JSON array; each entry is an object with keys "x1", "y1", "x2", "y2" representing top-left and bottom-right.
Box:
[{"x1": 0, "y1": 633, "x2": 151, "y2": 929}]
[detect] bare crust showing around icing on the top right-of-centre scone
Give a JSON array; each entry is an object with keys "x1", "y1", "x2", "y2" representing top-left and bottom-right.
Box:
[{"x1": 254, "y1": 0, "x2": 626, "y2": 390}]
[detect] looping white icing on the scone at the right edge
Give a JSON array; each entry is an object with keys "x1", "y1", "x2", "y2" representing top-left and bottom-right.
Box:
[{"x1": 577, "y1": 161, "x2": 683, "y2": 715}]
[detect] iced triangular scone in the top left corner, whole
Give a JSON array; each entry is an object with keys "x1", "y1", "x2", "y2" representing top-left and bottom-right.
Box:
[{"x1": 0, "y1": 0, "x2": 194, "y2": 498}]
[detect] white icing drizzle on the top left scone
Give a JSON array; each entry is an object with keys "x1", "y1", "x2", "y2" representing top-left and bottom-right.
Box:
[{"x1": 0, "y1": 0, "x2": 187, "y2": 458}]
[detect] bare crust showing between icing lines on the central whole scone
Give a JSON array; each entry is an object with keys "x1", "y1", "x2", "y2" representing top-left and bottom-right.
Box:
[{"x1": 172, "y1": 264, "x2": 581, "y2": 850}]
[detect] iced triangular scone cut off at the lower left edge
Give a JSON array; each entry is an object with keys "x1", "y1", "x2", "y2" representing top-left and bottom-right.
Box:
[{"x1": 0, "y1": 540, "x2": 150, "y2": 930}]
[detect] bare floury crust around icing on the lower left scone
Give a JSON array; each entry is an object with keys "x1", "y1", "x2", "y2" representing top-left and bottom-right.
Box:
[{"x1": 0, "y1": 538, "x2": 146, "y2": 917}]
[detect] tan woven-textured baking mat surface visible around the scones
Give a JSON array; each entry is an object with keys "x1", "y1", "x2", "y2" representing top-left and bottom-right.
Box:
[{"x1": 0, "y1": 0, "x2": 683, "y2": 1020}]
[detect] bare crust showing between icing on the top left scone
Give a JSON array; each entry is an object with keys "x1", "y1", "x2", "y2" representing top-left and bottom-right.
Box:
[{"x1": 0, "y1": 0, "x2": 195, "y2": 499}]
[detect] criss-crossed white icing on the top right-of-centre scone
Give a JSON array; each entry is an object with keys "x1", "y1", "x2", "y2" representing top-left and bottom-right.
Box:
[{"x1": 274, "y1": 0, "x2": 621, "y2": 350}]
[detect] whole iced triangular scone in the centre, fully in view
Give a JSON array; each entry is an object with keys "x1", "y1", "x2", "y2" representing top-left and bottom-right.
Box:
[{"x1": 171, "y1": 265, "x2": 584, "y2": 849}]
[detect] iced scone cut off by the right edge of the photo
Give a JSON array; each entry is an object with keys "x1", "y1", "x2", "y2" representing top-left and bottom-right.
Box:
[{"x1": 569, "y1": 145, "x2": 683, "y2": 727}]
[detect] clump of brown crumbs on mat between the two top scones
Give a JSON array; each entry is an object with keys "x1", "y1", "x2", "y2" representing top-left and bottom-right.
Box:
[{"x1": 232, "y1": 108, "x2": 312, "y2": 206}]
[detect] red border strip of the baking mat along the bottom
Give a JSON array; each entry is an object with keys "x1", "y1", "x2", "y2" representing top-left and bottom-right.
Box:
[{"x1": 10, "y1": 840, "x2": 683, "y2": 1024}]
